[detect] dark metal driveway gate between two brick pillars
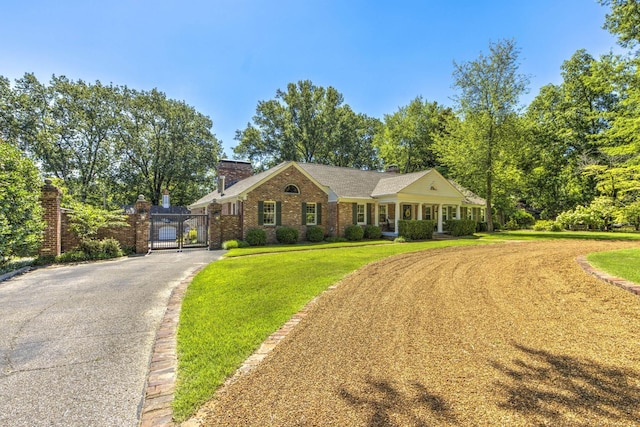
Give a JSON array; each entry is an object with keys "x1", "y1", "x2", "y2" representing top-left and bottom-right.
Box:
[{"x1": 149, "y1": 214, "x2": 209, "y2": 250}]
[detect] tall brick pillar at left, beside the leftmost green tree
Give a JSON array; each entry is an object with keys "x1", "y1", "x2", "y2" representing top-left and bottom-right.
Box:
[{"x1": 38, "y1": 179, "x2": 62, "y2": 256}]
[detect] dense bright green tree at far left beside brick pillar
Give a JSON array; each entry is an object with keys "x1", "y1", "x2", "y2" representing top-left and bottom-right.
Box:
[{"x1": 0, "y1": 139, "x2": 44, "y2": 266}]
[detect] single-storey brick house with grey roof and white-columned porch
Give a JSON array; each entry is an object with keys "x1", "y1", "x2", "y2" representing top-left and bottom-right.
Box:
[{"x1": 189, "y1": 160, "x2": 485, "y2": 241}]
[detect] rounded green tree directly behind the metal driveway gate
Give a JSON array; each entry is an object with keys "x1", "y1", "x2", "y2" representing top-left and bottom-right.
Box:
[{"x1": 115, "y1": 88, "x2": 222, "y2": 205}]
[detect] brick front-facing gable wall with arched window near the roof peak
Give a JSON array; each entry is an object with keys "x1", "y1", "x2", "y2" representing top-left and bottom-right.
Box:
[{"x1": 243, "y1": 165, "x2": 329, "y2": 243}]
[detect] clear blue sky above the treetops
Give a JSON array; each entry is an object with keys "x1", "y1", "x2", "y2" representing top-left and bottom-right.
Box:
[{"x1": 0, "y1": 0, "x2": 619, "y2": 156}]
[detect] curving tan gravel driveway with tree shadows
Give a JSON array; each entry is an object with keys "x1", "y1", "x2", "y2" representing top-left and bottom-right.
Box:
[{"x1": 194, "y1": 241, "x2": 640, "y2": 426}]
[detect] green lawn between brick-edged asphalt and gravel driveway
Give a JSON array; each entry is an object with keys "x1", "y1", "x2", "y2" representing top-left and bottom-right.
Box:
[{"x1": 173, "y1": 231, "x2": 640, "y2": 420}]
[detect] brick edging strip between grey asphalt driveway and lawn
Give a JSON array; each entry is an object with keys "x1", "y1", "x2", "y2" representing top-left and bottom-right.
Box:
[{"x1": 139, "y1": 265, "x2": 211, "y2": 427}]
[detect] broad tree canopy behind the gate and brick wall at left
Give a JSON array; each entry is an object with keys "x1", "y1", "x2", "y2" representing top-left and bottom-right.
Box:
[{"x1": 0, "y1": 74, "x2": 222, "y2": 208}]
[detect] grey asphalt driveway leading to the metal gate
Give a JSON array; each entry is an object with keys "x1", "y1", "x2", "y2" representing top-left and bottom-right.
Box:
[{"x1": 0, "y1": 250, "x2": 221, "y2": 427}]
